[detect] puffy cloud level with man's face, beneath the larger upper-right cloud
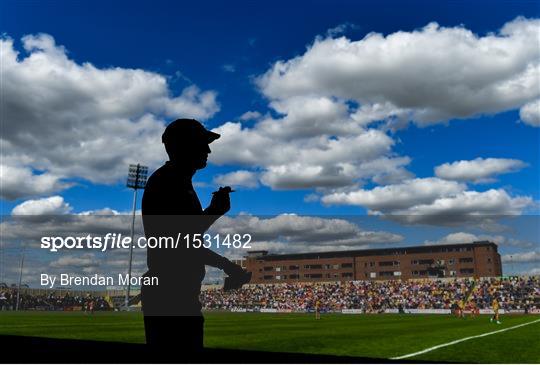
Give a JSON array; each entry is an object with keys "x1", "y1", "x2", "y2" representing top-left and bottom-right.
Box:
[{"x1": 210, "y1": 115, "x2": 404, "y2": 189}]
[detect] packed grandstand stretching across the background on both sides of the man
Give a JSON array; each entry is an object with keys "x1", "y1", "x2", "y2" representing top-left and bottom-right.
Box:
[{"x1": 0, "y1": 277, "x2": 540, "y2": 313}]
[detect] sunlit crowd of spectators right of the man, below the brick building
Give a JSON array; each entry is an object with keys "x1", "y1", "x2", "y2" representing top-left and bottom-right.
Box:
[{"x1": 200, "y1": 277, "x2": 540, "y2": 313}]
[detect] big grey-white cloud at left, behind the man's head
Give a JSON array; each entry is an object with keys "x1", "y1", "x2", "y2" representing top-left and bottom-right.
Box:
[{"x1": 0, "y1": 34, "x2": 219, "y2": 199}]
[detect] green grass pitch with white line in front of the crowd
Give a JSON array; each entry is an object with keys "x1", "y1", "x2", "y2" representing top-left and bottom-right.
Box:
[{"x1": 0, "y1": 312, "x2": 540, "y2": 363}]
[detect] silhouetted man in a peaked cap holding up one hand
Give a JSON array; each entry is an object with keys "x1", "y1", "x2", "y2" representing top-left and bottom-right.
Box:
[{"x1": 142, "y1": 119, "x2": 249, "y2": 356}]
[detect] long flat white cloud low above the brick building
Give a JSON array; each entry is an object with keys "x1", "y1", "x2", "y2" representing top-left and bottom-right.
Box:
[{"x1": 321, "y1": 178, "x2": 534, "y2": 224}]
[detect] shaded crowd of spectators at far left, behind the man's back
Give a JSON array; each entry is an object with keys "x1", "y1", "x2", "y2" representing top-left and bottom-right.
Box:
[{"x1": 0, "y1": 288, "x2": 110, "y2": 311}]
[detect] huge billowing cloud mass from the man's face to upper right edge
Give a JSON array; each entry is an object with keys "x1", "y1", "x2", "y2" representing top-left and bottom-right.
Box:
[{"x1": 210, "y1": 18, "x2": 540, "y2": 191}]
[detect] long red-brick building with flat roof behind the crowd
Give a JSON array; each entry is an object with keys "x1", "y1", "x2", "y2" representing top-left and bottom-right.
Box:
[{"x1": 243, "y1": 241, "x2": 502, "y2": 284}]
